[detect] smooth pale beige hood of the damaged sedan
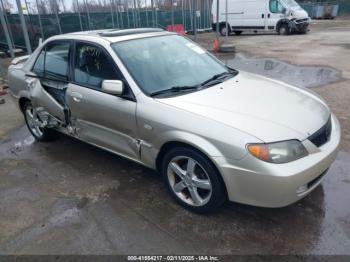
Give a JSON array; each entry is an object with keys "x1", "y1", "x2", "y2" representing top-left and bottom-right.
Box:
[{"x1": 157, "y1": 71, "x2": 330, "y2": 142}]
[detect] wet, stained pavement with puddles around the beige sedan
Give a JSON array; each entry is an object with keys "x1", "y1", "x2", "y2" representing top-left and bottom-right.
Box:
[{"x1": 0, "y1": 19, "x2": 350, "y2": 255}]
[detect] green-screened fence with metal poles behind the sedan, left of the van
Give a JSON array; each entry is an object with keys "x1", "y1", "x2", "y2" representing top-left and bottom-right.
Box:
[{"x1": 0, "y1": 0, "x2": 213, "y2": 53}]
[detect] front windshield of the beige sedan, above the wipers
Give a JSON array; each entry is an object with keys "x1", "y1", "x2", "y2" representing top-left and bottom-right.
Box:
[{"x1": 112, "y1": 35, "x2": 229, "y2": 95}]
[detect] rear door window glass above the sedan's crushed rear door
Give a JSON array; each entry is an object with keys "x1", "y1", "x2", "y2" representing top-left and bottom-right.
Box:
[{"x1": 33, "y1": 42, "x2": 70, "y2": 81}]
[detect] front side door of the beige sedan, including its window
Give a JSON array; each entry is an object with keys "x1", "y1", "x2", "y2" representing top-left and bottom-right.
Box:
[{"x1": 66, "y1": 41, "x2": 140, "y2": 160}]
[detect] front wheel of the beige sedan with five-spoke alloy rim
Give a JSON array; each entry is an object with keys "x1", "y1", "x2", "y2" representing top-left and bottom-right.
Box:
[{"x1": 161, "y1": 147, "x2": 226, "y2": 213}]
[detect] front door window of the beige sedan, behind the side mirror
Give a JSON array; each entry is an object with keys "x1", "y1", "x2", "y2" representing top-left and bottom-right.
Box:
[{"x1": 74, "y1": 43, "x2": 120, "y2": 89}]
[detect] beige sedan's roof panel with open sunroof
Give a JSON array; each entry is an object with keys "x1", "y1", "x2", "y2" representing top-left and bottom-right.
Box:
[{"x1": 51, "y1": 28, "x2": 175, "y2": 43}]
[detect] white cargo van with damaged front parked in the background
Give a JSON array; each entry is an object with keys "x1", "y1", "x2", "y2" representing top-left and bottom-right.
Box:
[{"x1": 212, "y1": 0, "x2": 310, "y2": 35}]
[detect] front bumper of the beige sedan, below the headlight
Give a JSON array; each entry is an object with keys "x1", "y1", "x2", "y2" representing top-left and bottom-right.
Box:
[{"x1": 215, "y1": 115, "x2": 341, "y2": 207}]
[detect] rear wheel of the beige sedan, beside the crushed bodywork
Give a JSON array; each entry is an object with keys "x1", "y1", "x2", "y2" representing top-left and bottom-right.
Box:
[{"x1": 22, "y1": 101, "x2": 56, "y2": 142}]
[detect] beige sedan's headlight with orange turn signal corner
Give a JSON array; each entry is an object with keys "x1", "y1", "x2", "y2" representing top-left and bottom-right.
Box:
[{"x1": 247, "y1": 140, "x2": 308, "y2": 164}]
